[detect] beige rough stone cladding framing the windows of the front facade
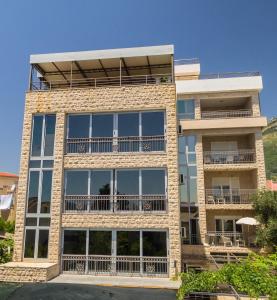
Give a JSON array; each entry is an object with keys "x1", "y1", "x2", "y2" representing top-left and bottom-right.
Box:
[{"x1": 14, "y1": 84, "x2": 181, "y2": 276}]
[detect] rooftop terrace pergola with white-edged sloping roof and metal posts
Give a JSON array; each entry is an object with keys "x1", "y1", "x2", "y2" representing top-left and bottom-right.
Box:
[{"x1": 29, "y1": 45, "x2": 174, "y2": 90}]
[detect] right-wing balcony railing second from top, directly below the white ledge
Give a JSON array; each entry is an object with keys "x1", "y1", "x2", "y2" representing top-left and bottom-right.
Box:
[{"x1": 204, "y1": 149, "x2": 255, "y2": 164}]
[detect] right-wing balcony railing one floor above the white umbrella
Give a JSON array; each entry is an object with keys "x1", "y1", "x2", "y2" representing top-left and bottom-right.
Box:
[{"x1": 206, "y1": 189, "x2": 256, "y2": 204}]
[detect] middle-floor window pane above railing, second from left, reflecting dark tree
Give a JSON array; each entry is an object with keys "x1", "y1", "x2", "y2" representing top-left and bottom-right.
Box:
[{"x1": 90, "y1": 171, "x2": 111, "y2": 195}]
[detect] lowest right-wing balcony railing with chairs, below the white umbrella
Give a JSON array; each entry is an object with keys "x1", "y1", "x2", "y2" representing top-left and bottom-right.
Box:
[{"x1": 206, "y1": 231, "x2": 246, "y2": 247}]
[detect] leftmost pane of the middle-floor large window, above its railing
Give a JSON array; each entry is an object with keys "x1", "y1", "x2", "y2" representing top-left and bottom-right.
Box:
[{"x1": 66, "y1": 171, "x2": 88, "y2": 195}]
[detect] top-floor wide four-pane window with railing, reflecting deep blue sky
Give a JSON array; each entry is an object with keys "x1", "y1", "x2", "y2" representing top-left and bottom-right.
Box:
[{"x1": 67, "y1": 111, "x2": 165, "y2": 153}]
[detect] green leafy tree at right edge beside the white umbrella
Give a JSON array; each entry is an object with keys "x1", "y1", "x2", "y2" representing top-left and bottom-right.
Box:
[{"x1": 253, "y1": 190, "x2": 277, "y2": 249}]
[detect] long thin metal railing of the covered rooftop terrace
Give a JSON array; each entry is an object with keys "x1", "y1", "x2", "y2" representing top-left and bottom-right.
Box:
[{"x1": 31, "y1": 74, "x2": 172, "y2": 91}]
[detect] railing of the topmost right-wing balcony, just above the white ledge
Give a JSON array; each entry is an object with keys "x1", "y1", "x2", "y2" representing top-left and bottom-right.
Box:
[{"x1": 201, "y1": 109, "x2": 252, "y2": 119}]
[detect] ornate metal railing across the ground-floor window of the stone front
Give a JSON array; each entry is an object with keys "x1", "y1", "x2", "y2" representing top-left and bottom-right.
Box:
[{"x1": 62, "y1": 255, "x2": 169, "y2": 277}]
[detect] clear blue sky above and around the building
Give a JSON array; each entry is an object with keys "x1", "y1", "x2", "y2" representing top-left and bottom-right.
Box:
[{"x1": 0, "y1": 0, "x2": 277, "y2": 172}]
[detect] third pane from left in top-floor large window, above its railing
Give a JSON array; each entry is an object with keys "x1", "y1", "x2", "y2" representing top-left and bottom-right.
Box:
[{"x1": 118, "y1": 113, "x2": 139, "y2": 136}]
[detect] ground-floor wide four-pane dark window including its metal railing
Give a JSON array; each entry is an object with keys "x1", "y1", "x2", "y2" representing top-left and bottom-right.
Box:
[{"x1": 62, "y1": 229, "x2": 169, "y2": 277}]
